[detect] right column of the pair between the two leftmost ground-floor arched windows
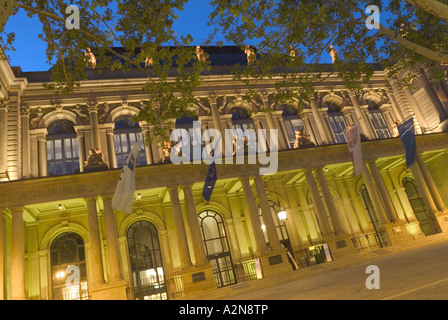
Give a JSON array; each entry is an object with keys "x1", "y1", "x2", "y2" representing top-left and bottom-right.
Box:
[{"x1": 103, "y1": 195, "x2": 123, "y2": 282}]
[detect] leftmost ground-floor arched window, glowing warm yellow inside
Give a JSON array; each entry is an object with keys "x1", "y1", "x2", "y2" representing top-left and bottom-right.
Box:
[{"x1": 50, "y1": 232, "x2": 88, "y2": 300}]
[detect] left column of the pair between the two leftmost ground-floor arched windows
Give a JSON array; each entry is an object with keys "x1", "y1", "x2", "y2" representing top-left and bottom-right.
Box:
[{"x1": 85, "y1": 197, "x2": 105, "y2": 286}]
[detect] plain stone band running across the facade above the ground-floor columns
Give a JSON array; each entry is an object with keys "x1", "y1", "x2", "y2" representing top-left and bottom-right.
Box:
[{"x1": 0, "y1": 132, "x2": 448, "y2": 208}]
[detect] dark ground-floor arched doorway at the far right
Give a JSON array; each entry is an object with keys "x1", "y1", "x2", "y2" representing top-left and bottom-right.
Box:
[{"x1": 402, "y1": 177, "x2": 437, "y2": 235}]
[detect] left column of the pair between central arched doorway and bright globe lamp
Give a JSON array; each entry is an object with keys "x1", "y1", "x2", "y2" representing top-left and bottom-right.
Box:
[{"x1": 240, "y1": 177, "x2": 269, "y2": 254}]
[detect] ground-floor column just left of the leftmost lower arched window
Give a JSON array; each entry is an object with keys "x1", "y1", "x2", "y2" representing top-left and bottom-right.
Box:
[{"x1": 10, "y1": 207, "x2": 26, "y2": 300}]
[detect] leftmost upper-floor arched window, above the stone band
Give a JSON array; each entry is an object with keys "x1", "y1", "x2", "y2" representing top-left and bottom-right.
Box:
[{"x1": 47, "y1": 120, "x2": 79, "y2": 176}]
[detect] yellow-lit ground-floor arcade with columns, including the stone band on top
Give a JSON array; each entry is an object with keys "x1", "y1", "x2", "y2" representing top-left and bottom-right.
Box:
[{"x1": 0, "y1": 133, "x2": 448, "y2": 299}]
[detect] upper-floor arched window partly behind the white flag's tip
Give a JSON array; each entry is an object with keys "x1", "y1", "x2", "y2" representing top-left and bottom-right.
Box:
[{"x1": 114, "y1": 116, "x2": 147, "y2": 168}]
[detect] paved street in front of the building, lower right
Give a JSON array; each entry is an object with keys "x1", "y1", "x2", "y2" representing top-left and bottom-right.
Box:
[{"x1": 224, "y1": 241, "x2": 448, "y2": 300}]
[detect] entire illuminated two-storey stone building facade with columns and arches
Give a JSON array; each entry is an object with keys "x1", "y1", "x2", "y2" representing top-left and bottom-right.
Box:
[{"x1": 0, "y1": 48, "x2": 448, "y2": 300}]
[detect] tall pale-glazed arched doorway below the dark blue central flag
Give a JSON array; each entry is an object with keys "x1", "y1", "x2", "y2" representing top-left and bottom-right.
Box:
[{"x1": 198, "y1": 210, "x2": 236, "y2": 288}]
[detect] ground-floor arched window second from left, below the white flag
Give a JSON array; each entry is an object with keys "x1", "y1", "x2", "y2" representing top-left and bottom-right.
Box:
[{"x1": 127, "y1": 221, "x2": 167, "y2": 300}]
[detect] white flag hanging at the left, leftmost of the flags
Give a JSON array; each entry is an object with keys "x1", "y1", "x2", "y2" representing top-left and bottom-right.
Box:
[{"x1": 112, "y1": 139, "x2": 140, "y2": 213}]
